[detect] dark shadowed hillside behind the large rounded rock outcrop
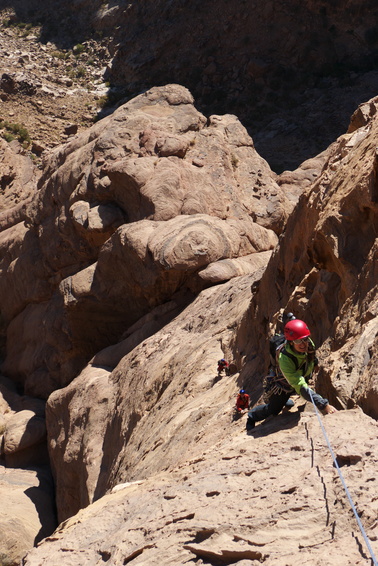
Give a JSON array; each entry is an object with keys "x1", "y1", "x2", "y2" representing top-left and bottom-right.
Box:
[{"x1": 0, "y1": 0, "x2": 378, "y2": 173}]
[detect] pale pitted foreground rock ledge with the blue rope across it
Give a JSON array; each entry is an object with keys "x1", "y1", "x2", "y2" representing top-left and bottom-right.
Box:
[{"x1": 23, "y1": 410, "x2": 378, "y2": 566}]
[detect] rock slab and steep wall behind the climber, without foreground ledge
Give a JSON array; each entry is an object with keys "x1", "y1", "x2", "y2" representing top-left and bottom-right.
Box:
[{"x1": 34, "y1": 93, "x2": 378, "y2": 552}]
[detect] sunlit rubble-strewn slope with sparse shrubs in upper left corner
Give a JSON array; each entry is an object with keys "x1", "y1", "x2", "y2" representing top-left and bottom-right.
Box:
[{"x1": 0, "y1": 7, "x2": 110, "y2": 158}]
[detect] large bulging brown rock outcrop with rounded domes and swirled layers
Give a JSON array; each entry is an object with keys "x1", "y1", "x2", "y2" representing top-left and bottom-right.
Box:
[{"x1": 0, "y1": 85, "x2": 286, "y2": 397}]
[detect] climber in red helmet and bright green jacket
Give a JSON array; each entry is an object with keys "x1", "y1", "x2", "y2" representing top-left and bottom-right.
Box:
[{"x1": 247, "y1": 319, "x2": 336, "y2": 430}]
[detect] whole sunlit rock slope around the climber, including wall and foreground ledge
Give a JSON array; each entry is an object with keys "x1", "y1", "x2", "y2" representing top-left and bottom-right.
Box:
[{"x1": 12, "y1": 90, "x2": 378, "y2": 565}]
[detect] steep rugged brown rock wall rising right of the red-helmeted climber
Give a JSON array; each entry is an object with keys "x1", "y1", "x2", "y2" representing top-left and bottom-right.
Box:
[{"x1": 235, "y1": 95, "x2": 378, "y2": 418}]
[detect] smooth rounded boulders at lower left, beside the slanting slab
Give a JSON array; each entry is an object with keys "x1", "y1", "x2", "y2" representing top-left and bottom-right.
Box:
[{"x1": 0, "y1": 377, "x2": 57, "y2": 566}]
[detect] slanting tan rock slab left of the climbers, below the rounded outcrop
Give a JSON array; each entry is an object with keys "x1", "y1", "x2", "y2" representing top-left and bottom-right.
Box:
[{"x1": 46, "y1": 276, "x2": 253, "y2": 520}]
